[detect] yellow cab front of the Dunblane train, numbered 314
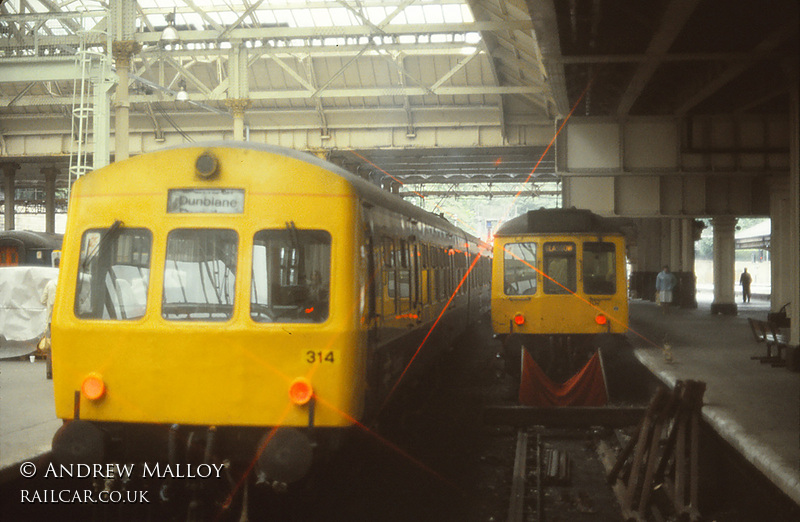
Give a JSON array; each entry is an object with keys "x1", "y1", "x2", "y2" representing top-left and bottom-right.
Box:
[{"x1": 52, "y1": 148, "x2": 365, "y2": 426}]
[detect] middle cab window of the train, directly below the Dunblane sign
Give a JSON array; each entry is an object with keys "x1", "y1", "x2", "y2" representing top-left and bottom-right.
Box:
[{"x1": 161, "y1": 229, "x2": 239, "y2": 321}]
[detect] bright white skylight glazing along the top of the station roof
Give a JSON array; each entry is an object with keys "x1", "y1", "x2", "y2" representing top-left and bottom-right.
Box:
[{"x1": 0, "y1": 0, "x2": 480, "y2": 47}]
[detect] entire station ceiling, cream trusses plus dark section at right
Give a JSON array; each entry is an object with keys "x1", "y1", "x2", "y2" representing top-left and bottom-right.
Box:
[{"x1": 0, "y1": 0, "x2": 800, "y2": 201}]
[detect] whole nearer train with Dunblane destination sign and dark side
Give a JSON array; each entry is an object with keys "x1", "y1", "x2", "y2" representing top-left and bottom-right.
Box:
[{"x1": 52, "y1": 144, "x2": 489, "y2": 504}]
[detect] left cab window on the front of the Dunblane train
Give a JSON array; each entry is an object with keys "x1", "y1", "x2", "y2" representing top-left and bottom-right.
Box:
[{"x1": 74, "y1": 221, "x2": 153, "y2": 320}]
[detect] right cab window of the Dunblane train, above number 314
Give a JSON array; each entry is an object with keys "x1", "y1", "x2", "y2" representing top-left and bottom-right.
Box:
[{"x1": 250, "y1": 225, "x2": 331, "y2": 323}]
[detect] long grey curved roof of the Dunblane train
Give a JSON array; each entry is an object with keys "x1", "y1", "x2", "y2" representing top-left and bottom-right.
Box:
[{"x1": 155, "y1": 141, "x2": 483, "y2": 248}]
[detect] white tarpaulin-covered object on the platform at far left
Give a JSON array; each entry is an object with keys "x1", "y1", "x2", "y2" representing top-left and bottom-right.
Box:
[{"x1": 0, "y1": 266, "x2": 58, "y2": 342}]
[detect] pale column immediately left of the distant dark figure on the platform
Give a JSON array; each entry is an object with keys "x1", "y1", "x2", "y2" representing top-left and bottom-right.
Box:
[{"x1": 711, "y1": 216, "x2": 738, "y2": 315}]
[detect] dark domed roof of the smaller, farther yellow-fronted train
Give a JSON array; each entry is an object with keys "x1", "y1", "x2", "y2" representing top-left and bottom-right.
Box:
[{"x1": 494, "y1": 208, "x2": 622, "y2": 237}]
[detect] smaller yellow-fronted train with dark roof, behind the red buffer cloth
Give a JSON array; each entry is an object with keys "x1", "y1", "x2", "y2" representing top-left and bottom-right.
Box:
[{"x1": 491, "y1": 208, "x2": 628, "y2": 381}]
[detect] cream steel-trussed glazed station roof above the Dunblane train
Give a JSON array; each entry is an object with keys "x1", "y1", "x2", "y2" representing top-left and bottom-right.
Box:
[{"x1": 0, "y1": 0, "x2": 556, "y2": 187}]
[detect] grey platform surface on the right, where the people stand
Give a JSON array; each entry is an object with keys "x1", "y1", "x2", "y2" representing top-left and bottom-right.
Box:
[{"x1": 628, "y1": 293, "x2": 800, "y2": 505}]
